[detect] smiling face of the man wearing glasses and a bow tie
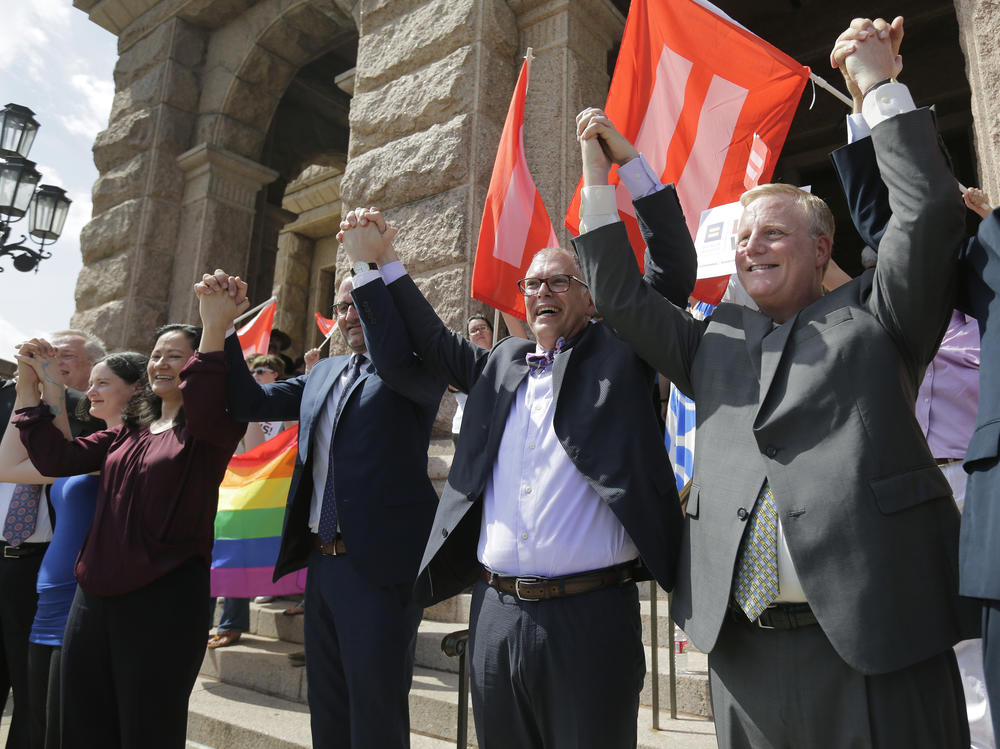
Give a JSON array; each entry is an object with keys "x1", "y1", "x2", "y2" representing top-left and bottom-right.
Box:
[{"x1": 524, "y1": 250, "x2": 595, "y2": 351}]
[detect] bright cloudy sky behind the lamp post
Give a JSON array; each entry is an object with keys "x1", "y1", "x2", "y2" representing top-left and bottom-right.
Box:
[{"x1": 0, "y1": 0, "x2": 118, "y2": 361}]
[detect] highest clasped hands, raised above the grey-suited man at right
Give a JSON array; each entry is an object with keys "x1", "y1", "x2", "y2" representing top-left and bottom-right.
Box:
[{"x1": 830, "y1": 16, "x2": 903, "y2": 112}]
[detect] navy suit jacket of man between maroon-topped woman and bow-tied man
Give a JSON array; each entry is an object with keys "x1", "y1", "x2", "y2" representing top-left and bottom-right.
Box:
[{"x1": 226, "y1": 326, "x2": 444, "y2": 585}]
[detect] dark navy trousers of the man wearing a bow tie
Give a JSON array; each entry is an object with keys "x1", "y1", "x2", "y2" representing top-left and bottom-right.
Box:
[{"x1": 466, "y1": 581, "x2": 646, "y2": 749}]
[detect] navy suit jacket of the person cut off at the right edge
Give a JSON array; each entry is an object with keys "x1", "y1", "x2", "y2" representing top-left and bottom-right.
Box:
[{"x1": 831, "y1": 138, "x2": 1000, "y2": 600}]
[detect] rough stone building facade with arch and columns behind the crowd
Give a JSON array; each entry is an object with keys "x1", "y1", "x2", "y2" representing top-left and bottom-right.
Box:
[{"x1": 73, "y1": 0, "x2": 1000, "y2": 394}]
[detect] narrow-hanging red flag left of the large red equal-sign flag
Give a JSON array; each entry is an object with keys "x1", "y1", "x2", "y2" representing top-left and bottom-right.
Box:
[{"x1": 472, "y1": 47, "x2": 559, "y2": 320}]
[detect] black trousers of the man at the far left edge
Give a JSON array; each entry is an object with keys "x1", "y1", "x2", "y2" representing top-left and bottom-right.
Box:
[{"x1": 0, "y1": 554, "x2": 42, "y2": 749}]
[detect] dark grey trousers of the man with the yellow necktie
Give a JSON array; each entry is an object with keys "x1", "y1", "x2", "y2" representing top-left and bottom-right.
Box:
[{"x1": 708, "y1": 618, "x2": 969, "y2": 749}]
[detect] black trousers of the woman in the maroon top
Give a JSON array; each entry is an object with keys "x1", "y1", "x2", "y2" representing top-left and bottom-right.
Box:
[{"x1": 61, "y1": 559, "x2": 210, "y2": 749}]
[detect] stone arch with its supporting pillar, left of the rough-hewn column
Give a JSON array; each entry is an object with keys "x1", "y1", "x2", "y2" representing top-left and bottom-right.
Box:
[{"x1": 171, "y1": 0, "x2": 357, "y2": 328}]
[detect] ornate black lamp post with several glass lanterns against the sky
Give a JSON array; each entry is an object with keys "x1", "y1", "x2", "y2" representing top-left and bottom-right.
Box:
[{"x1": 0, "y1": 104, "x2": 72, "y2": 273}]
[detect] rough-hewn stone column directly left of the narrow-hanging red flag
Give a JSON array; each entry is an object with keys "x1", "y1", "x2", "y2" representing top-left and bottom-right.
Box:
[{"x1": 340, "y1": 0, "x2": 518, "y2": 328}]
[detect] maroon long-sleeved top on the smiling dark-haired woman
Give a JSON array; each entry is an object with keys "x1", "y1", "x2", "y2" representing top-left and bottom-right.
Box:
[{"x1": 13, "y1": 351, "x2": 246, "y2": 596}]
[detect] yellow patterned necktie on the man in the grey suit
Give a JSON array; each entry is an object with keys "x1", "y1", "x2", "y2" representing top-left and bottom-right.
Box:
[{"x1": 733, "y1": 479, "x2": 778, "y2": 621}]
